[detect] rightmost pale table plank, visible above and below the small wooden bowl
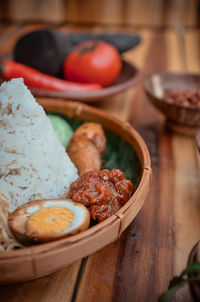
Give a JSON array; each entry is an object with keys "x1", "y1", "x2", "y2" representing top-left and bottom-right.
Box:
[{"x1": 172, "y1": 29, "x2": 200, "y2": 302}]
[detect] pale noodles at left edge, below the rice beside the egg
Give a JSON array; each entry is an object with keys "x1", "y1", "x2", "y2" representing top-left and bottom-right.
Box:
[{"x1": 0, "y1": 195, "x2": 23, "y2": 252}]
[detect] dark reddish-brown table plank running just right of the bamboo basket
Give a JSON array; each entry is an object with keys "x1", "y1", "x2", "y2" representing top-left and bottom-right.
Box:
[{"x1": 127, "y1": 31, "x2": 174, "y2": 301}]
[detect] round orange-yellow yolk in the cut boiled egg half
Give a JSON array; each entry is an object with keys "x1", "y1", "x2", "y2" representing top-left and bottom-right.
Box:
[{"x1": 26, "y1": 207, "x2": 74, "y2": 236}]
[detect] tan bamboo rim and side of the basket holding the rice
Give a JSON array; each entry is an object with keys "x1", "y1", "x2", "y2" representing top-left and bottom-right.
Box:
[{"x1": 0, "y1": 99, "x2": 151, "y2": 284}]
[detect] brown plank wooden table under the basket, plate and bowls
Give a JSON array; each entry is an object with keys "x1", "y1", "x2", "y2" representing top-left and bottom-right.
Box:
[{"x1": 0, "y1": 24, "x2": 200, "y2": 302}]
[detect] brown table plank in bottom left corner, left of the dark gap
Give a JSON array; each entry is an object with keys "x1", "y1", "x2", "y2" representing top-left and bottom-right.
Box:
[{"x1": 0, "y1": 260, "x2": 81, "y2": 302}]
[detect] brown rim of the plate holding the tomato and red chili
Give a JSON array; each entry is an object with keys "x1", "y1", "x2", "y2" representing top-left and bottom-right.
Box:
[{"x1": 0, "y1": 55, "x2": 140, "y2": 102}]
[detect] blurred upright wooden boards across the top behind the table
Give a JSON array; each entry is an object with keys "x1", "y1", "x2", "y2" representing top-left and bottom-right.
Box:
[{"x1": 0, "y1": 0, "x2": 200, "y2": 26}]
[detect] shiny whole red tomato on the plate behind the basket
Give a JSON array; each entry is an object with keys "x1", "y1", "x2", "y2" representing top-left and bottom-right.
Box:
[{"x1": 63, "y1": 41, "x2": 122, "y2": 86}]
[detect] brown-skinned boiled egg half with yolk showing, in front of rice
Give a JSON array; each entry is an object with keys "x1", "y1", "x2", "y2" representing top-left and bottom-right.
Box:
[{"x1": 8, "y1": 199, "x2": 90, "y2": 245}]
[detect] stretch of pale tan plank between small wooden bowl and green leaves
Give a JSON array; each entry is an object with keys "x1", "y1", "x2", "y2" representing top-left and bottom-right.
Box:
[{"x1": 172, "y1": 135, "x2": 200, "y2": 274}]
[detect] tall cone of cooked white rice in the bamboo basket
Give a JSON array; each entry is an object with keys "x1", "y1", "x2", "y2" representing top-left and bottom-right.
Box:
[{"x1": 0, "y1": 79, "x2": 78, "y2": 210}]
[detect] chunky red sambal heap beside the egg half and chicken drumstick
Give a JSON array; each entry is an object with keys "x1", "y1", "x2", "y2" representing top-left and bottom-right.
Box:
[{"x1": 67, "y1": 169, "x2": 134, "y2": 222}]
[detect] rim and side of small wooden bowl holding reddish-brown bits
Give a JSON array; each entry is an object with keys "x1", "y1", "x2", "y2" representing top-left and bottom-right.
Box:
[{"x1": 144, "y1": 72, "x2": 200, "y2": 135}]
